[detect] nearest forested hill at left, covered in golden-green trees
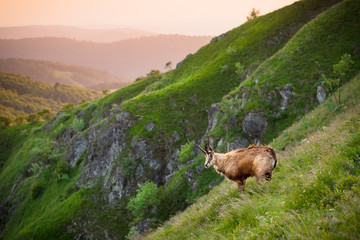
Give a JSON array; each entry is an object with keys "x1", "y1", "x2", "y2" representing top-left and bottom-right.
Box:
[{"x1": 0, "y1": 73, "x2": 102, "y2": 118}]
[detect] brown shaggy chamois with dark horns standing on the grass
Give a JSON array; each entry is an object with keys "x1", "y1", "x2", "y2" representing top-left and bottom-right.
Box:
[{"x1": 199, "y1": 144, "x2": 277, "y2": 192}]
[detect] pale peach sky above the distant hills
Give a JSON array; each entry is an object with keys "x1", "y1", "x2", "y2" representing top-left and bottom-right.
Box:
[{"x1": 0, "y1": 0, "x2": 296, "y2": 35}]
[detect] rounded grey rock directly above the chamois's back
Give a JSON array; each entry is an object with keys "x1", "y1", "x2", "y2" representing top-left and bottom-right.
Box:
[{"x1": 242, "y1": 112, "x2": 268, "y2": 140}]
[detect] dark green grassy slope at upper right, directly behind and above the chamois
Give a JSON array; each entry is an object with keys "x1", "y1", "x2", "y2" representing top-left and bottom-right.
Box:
[{"x1": 214, "y1": 0, "x2": 360, "y2": 143}]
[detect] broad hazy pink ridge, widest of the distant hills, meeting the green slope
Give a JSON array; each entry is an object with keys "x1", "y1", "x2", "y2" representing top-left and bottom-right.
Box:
[{"x1": 0, "y1": 35, "x2": 214, "y2": 79}]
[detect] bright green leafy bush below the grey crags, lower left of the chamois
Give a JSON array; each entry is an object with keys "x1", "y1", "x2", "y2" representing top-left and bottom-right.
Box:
[{"x1": 127, "y1": 182, "x2": 160, "y2": 219}]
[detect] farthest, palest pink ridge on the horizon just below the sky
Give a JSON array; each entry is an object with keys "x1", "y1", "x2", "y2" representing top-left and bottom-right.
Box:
[{"x1": 0, "y1": 25, "x2": 156, "y2": 42}]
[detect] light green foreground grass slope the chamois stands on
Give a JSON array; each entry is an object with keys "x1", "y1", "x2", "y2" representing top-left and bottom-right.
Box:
[{"x1": 145, "y1": 72, "x2": 360, "y2": 239}]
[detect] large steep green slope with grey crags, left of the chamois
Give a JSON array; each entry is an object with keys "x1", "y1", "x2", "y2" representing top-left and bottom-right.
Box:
[{"x1": 0, "y1": 0, "x2": 359, "y2": 239}]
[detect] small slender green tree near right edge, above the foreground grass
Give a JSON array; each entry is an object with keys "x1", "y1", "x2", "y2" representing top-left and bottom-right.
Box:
[{"x1": 321, "y1": 54, "x2": 354, "y2": 107}]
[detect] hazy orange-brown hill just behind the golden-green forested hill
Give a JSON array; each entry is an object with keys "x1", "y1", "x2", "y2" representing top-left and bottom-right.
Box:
[{"x1": 0, "y1": 58, "x2": 132, "y2": 91}]
